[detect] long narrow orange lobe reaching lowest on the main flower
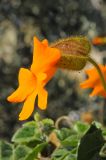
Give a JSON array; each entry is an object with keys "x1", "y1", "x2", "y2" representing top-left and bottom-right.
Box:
[{"x1": 19, "y1": 90, "x2": 37, "y2": 121}]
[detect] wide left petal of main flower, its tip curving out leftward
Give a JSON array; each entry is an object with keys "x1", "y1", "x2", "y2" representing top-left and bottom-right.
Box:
[{"x1": 7, "y1": 68, "x2": 36, "y2": 102}]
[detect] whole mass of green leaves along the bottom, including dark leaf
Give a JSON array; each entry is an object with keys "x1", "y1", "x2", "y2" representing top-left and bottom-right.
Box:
[{"x1": 0, "y1": 114, "x2": 106, "y2": 160}]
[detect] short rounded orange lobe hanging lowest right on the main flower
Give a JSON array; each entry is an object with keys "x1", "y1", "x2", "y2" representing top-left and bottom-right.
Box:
[{"x1": 38, "y1": 88, "x2": 48, "y2": 110}]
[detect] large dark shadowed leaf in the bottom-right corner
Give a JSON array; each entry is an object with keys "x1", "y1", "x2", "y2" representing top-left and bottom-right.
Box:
[{"x1": 78, "y1": 124, "x2": 104, "y2": 160}]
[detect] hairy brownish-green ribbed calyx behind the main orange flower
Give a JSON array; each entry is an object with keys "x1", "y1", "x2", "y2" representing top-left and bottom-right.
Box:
[{"x1": 51, "y1": 36, "x2": 91, "y2": 70}]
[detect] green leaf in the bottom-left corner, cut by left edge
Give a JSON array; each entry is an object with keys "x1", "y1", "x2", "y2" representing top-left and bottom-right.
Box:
[{"x1": 0, "y1": 141, "x2": 13, "y2": 160}]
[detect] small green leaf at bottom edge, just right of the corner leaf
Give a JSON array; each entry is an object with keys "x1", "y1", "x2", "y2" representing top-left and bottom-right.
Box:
[{"x1": 14, "y1": 145, "x2": 31, "y2": 160}]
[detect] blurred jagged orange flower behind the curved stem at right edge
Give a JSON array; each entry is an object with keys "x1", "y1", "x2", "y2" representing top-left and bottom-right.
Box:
[{"x1": 80, "y1": 65, "x2": 106, "y2": 97}]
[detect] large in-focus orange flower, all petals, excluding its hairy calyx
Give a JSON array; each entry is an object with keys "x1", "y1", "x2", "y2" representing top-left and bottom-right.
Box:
[{"x1": 7, "y1": 37, "x2": 60, "y2": 120}]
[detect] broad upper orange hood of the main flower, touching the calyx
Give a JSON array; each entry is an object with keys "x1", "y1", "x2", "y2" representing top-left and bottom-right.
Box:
[{"x1": 31, "y1": 37, "x2": 60, "y2": 75}]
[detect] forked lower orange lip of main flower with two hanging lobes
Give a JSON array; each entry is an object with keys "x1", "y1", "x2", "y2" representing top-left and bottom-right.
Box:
[{"x1": 19, "y1": 73, "x2": 47, "y2": 120}]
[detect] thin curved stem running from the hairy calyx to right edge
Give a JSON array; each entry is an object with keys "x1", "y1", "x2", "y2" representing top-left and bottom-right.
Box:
[{"x1": 88, "y1": 57, "x2": 106, "y2": 90}]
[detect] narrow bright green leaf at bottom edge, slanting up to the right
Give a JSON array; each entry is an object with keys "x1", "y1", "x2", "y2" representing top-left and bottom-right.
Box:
[{"x1": 25, "y1": 142, "x2": 47, "y2": 160}]
